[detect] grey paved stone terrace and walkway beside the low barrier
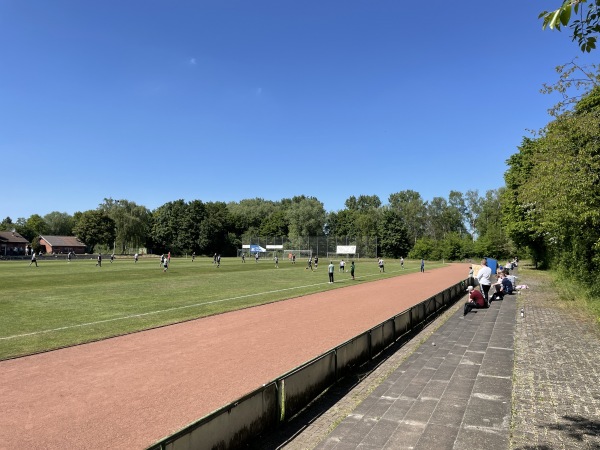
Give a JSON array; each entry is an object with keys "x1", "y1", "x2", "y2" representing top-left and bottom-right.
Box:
[{"x1": 270, "y1": 268, "x2": 600, "y2": 450}]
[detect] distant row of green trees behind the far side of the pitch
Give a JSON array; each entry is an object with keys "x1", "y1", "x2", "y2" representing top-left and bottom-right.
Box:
[{"x1": 0, "y1": 188, "x2": 514, "y2": 260}]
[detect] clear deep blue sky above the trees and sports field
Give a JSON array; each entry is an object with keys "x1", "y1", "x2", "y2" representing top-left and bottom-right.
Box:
[{"x1": 0, "y1": 0, "x2": 597, "y2": 220}]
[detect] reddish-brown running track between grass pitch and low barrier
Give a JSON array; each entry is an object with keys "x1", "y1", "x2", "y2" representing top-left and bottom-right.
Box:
[{"x1": 0, "y1": 264, "x2": 468, "y2": 450}]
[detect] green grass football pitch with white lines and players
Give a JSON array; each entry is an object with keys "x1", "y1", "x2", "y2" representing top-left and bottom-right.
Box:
[{"x1": 0, "y1": 257, "x2": 442, "y2": 360}]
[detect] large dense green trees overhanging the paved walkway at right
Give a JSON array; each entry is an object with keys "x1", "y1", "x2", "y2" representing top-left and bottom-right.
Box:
[{"x1": 503, "y1": 82, "x2": 600, "y2": 290}]
